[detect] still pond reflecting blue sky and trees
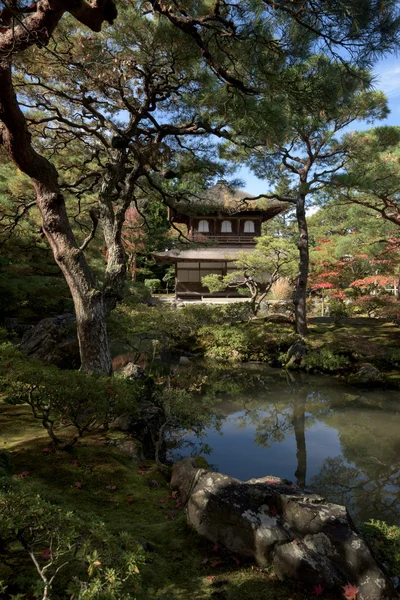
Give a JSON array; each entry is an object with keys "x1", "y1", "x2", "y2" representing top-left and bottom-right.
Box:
[{"x1": 171, "y1": 365, "x2": 400, "y2": 524}]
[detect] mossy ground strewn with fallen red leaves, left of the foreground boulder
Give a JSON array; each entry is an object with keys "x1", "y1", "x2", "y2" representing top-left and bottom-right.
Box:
[{"x1": 0, "y1": 404, "x2": 342, "y2": 600}]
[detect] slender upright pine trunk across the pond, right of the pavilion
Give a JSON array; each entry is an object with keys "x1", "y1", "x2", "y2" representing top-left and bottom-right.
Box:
[{"x1": 294, "y1": 192, "x2": 309, "y2": 338}]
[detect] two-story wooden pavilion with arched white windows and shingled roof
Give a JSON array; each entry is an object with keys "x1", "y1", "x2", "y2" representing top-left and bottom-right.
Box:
[{"x1": 153, "y1": 181, "x2": 287, "y2": 298}]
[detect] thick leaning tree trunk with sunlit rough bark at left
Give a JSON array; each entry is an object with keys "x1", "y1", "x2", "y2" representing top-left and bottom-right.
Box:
[{"x1": 0, "y1": 58, "x2": 112, "y2": 374}]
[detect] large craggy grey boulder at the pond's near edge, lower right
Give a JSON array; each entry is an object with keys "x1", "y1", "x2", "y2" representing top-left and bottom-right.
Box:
[{"x1": 171, "y1": 458, "x2": 399, "y2": 600}]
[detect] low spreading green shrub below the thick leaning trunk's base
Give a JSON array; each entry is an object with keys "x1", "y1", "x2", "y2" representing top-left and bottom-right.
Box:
[{"x1": 0, "y1": 344, "x2": 143, "y2": 445}]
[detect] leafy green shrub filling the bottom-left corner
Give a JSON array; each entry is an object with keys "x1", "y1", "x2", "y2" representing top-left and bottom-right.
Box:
[{"x1": 0, "y1": 484, "x2": 144, "y2": 600}]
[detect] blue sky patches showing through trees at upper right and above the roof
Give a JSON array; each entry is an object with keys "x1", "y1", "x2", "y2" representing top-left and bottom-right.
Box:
[{"x1": 236, "y1": 55, "x2": 400, "y2": 196}]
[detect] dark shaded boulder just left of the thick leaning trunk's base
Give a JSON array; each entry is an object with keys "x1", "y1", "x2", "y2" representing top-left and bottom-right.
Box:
[{"x1": 19, "y1": 313, "x2": 81, "y2": 369}]
